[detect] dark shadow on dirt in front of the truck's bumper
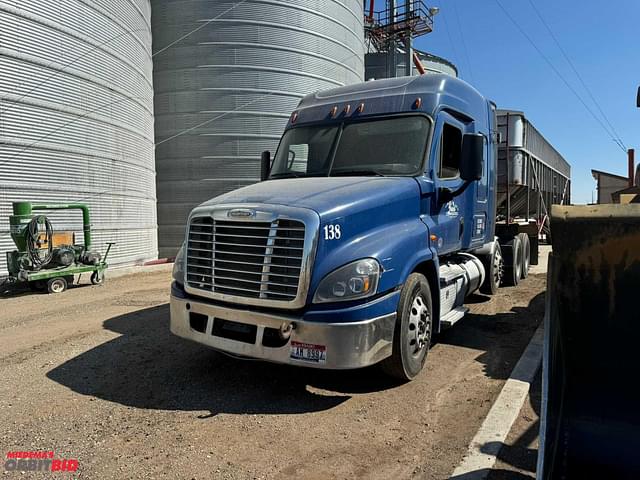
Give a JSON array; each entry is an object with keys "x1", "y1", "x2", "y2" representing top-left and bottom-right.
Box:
[{"x1": 47, "y1": 304, "x2": 404, "y2": 417}]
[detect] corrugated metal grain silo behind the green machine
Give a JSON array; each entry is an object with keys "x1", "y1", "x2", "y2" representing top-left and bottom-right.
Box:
[{"x1": 0, "y1": 0, "x2": 157, "y2": 274}]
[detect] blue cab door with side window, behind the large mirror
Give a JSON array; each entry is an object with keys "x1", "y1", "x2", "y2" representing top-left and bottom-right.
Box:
[{"x1": 431, "y1": 112, "x2": 472, "y2": 255}]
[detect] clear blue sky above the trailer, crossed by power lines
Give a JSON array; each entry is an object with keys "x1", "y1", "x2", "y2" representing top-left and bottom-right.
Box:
[{"x1": 408, "y1": 0, "x2": 640, "y2": 203}]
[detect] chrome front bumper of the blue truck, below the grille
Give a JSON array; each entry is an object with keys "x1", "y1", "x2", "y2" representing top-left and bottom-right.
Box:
[{"x1": 171, "y1": 295, "x2": 396, "y2": 369}]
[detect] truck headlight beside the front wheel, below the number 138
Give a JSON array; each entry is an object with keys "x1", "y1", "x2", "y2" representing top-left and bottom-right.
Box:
[{"x1": 313, "y1": 258, "x2": 380, "y2": 303}]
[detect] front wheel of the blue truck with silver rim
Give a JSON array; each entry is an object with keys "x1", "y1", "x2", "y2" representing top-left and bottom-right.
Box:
[{"x1": 380, "y1": 273, "x2": 433, "y2": 382}]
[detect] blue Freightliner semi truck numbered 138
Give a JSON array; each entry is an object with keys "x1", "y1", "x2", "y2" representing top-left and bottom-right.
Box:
[{"x1": 171, "y1": 75, "x2": 560, "y2": 380}]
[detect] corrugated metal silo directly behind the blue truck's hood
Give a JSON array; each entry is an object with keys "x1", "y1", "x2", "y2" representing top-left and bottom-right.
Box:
[{"x1": 152, "y1": 0, "x2": 364, "y2": 256}]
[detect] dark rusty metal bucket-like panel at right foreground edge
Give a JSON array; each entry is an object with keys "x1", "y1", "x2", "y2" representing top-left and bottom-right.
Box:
[{"x1": 537, "y1": 205, "x2": 640, "y2": 479}]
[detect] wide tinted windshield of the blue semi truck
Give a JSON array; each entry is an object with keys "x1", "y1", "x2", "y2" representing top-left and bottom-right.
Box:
[{"x1": 269, "y1": 115, "x2": 430, "y2": 178}]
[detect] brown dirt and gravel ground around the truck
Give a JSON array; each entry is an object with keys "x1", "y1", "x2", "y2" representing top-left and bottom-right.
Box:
[{"x1": 0, "y1": 271, "x2": 545, "y2": 479}]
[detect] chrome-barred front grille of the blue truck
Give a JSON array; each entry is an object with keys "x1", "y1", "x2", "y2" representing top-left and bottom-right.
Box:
[{"x1": 186, "y1": 216, "x2": 305, "y2": 302}]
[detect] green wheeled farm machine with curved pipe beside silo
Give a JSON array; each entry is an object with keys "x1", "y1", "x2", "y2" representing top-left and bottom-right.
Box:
[{"x1": 7, "y1": 202, "x2": 113, "y2": 293}]
